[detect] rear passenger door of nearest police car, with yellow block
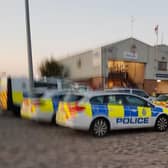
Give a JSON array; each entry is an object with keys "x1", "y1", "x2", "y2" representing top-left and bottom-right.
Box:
[{"x1": 107, "y1": 95, "x2": 131, "y2": 129}]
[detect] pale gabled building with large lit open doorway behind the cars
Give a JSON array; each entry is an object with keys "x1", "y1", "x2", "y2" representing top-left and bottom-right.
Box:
[{"x1": 60, "y1": 38, "x2": 168, "y2": 94}]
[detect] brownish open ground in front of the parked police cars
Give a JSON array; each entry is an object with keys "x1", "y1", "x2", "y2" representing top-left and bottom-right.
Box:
[{"x1": 0, "y1": 111, "x2": 168, "y2": 168}]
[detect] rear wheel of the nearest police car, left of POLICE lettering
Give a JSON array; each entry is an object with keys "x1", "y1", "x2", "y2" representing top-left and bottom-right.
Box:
[{"x1": 90, "y1": 118, "x2": 109, "y2": 137}]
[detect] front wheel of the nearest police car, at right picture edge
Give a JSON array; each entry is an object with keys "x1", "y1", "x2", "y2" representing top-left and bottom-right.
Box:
[{"x1": 155, "y1": 115, "x2": 168, "y2": 132}]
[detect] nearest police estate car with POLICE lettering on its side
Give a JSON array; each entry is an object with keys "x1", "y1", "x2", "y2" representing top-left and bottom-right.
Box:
[{"x1": 56, "y1": 92, "x2": 168, "y2": 137}]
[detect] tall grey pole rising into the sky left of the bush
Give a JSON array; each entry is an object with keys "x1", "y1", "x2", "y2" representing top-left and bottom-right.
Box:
[{"x1": 25, "y1": 0, "x2": 34, "y2": 94}]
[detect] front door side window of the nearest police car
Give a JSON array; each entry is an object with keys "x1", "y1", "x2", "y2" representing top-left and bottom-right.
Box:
[{"x1": 126, "y1": 96, "x2": 148, "y2": 107}]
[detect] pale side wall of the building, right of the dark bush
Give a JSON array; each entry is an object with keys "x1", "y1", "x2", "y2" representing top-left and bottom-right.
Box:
[{"x1": 60, "y1": 48, "x2": 101, "y2": 79}]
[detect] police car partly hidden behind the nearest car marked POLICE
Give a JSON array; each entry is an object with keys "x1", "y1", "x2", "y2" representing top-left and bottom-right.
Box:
[{"x1": 21, "y1": 89, "x2": 67, "y2": 122}]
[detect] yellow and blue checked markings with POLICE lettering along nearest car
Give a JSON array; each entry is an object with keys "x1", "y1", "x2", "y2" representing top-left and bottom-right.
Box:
[{"x1": 57, "y1": 102, "x2": 168, "y2": 124}]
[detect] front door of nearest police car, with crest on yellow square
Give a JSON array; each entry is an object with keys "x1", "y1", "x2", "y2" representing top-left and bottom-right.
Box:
[{"x1": 125, "y1": 95, "x2": 152, "y2": 128}]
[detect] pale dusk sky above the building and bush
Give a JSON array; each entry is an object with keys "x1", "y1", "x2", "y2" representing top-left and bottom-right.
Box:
[{"x1": 0, "y1": 0, "x2": 168, "y2": 77}]
